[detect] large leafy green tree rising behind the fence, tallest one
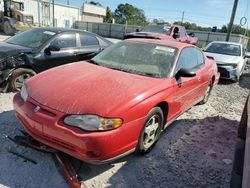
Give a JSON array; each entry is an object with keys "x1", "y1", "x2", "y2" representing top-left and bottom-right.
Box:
[{"x1": 114, "y1": 3, "x2": 147, "y2": 25}]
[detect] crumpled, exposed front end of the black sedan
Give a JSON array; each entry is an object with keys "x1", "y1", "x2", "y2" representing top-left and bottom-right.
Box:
[{"x1": 0, "y1": 53, "x2": 27, "y2": 92}]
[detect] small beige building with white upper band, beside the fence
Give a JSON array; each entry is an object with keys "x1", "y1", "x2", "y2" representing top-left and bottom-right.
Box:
[{"x1": 82, "y1": 3, "x2": 106, "y2": 23}]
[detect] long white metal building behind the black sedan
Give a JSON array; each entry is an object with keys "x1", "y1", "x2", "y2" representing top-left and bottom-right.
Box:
[{"x1": 24, "y1": 0, "x2": 81, "y2": 28}]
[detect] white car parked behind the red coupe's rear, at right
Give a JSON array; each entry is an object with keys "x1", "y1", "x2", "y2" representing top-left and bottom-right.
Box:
[{"x1": 204, "y1": 41, "x2": 250, "y2": 81}]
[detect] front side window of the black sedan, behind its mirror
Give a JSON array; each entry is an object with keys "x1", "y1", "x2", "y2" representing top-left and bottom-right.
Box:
[{"x1": 50, "y1": 33, "x2": 76, "y2": 49}]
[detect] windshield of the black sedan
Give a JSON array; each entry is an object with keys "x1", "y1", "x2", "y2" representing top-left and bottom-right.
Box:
[{"x1": 5, "y1": 29, "x2": 56, "y2": 48}]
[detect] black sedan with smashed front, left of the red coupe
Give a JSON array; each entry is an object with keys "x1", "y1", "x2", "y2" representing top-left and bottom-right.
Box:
[{"x1": 0, "y1": 28, "x2": 112, "y2": 91}]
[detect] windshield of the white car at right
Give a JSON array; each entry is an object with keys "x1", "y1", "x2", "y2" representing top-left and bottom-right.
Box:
[{"x1": 205, "y1": 43, "x2": 241, "y2": 56}]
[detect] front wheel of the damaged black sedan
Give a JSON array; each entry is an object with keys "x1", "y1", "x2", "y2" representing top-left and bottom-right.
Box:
[{"x1": 9, "y1": 68, "x2": 36, "y2": 91}]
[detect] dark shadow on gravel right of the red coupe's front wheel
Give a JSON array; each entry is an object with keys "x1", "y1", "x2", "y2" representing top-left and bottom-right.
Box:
[{"x1": 76, "y1": 117, "x2": 239, "y2": 188}]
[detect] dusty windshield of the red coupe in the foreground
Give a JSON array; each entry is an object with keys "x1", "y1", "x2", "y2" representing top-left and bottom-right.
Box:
[{"x1": 92, "y1": 41, "x2": 177, "y2": 78}]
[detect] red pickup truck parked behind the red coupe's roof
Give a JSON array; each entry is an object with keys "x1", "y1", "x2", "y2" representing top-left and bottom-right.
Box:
[{"x1": 124, "y1": 25, "x2": 198, "y2": 46}]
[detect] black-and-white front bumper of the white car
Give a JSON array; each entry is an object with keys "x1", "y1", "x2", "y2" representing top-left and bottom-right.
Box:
[{"x1": 217, "y1": 64, "x2": 239, "y2": 80}]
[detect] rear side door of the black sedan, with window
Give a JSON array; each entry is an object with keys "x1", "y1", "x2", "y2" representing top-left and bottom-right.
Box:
[{"x1": 77, "y1": 33, "x2": 104, "y2": 61}]
